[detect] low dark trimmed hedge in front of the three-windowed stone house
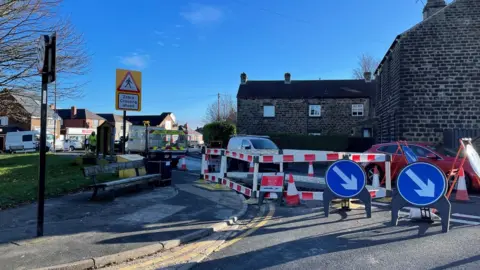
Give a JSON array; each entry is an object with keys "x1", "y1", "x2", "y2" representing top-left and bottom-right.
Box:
[{"x1": 269, "y1": 134, "x2": 374, "y2": 152}]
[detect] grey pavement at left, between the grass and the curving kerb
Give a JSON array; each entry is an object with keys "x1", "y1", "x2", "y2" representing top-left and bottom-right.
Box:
[{"x1": 0, "y1": 171, "x2": 245, "y2": 269}]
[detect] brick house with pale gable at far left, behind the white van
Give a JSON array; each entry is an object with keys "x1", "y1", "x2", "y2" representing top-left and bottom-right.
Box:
[{"x1": 0, "y1": 90, "x2": 62, "y2": 137}]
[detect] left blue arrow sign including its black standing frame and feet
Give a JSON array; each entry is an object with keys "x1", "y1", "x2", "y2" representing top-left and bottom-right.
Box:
[{"x1": 323, "y1": 159, "x2": 372, "y2": 218}]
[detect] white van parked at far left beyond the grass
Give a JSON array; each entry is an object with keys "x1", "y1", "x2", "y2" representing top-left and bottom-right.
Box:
[{"x1": 5, "y1": 131, "x2": 40, "y2": 153}]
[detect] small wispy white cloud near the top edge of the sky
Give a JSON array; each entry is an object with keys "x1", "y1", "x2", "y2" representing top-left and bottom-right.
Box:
[{"x1": 180, "y1": 4, "x2": 223, "y2": 25}]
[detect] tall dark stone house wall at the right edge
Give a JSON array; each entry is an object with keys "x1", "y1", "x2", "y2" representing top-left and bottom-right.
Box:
[{"x1": 375, "y1": 0, "x2": 480, "y2": 142}]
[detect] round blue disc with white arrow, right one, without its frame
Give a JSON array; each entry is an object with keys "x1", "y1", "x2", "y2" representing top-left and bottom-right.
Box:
[{"x1": 397, "y1": 162, "x2": 447, "y2": 206}]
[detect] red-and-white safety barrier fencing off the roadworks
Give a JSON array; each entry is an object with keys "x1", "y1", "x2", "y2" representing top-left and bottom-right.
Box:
[{"x1": 202, "y1": 148, "x2": 392, "y2": 201}]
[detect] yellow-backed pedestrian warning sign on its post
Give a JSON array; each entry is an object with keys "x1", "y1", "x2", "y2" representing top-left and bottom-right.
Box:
[{"x1": 115, "y1": 69, "x2": 142, "y2": 154}]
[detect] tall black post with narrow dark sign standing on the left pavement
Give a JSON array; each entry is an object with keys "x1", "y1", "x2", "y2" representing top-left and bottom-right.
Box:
[{"x1": 37, "y1": 34, "x2": 56, "y2": 237}]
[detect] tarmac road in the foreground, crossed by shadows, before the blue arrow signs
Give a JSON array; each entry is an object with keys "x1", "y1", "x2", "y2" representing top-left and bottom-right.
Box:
[{"x1": 193, "y1": 203, "x2": 480, "y2": 270}]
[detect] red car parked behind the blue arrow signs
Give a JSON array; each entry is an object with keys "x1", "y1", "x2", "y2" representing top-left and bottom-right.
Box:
[{"x1": 365, "y1": 142, "x2": 480, "y2": 191}]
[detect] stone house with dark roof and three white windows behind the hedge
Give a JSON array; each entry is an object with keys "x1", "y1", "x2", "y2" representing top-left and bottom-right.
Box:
[{"x1": 237, "y1": 73, "x2": 376, "y2": 137}]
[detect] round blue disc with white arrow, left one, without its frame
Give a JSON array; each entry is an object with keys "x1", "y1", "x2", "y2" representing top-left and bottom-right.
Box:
[{"x1": 325, "y1": 160, "x2": 367, "y2": 198}]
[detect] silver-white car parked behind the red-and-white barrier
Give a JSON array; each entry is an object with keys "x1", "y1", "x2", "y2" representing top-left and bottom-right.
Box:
[{"x1": 227, "y1": 135, "x2": 287, "y2": 172}]
